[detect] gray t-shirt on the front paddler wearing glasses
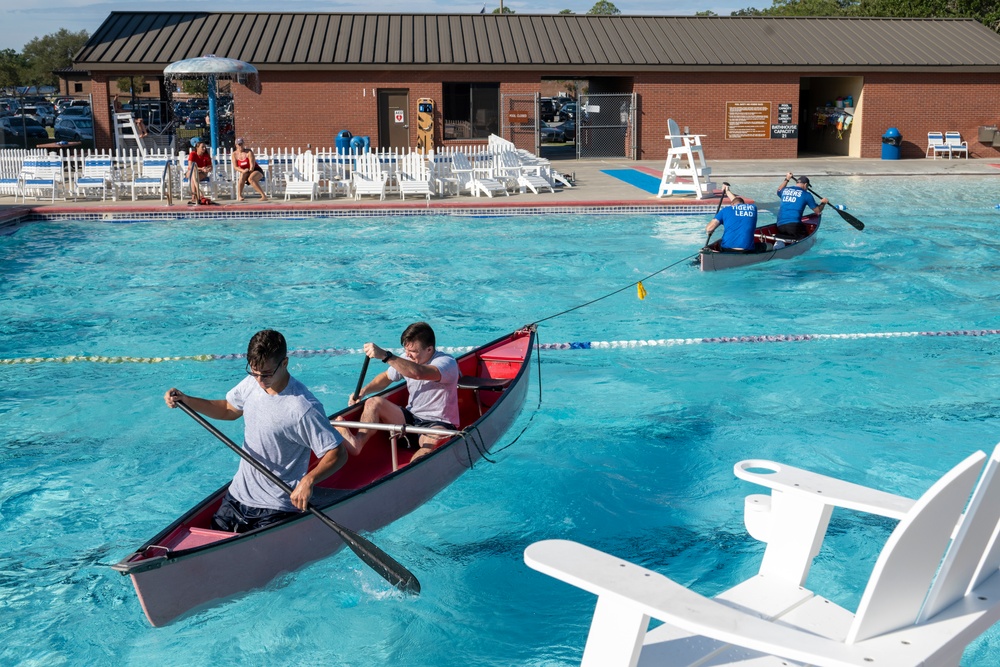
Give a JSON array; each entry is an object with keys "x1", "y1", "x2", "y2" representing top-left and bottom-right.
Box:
[{"x1": 226, "y1": 377, "x2": 342, "y2": 512}]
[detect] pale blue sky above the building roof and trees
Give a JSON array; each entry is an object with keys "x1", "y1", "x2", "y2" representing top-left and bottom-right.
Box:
[{"x1": 0, "y1": 0, "x2": 756, "y2": 52}]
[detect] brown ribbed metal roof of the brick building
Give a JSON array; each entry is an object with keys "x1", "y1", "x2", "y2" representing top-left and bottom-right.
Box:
[{"x1": 74, "y1": 12, "x2": 1000, "y2": 73}]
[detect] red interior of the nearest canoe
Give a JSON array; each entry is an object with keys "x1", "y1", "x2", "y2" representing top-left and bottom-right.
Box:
[{"x1": 121, "y1": 331, "x2": 532, "y2": 563}]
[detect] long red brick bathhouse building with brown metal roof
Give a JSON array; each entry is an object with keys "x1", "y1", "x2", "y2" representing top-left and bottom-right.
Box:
[{"x1": 74, "y1": 12, "x2": 1000, "y2": 159}]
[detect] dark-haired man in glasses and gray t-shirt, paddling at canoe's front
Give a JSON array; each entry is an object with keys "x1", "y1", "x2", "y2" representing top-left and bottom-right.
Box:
[{"x1": 164, "y1": 329, "x2": 347, "y2": 533}]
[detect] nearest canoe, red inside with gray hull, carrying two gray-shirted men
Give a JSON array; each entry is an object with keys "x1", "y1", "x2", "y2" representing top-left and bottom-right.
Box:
[{"x1": 113, "y1": 326, "x2": 535, "y2": 626}]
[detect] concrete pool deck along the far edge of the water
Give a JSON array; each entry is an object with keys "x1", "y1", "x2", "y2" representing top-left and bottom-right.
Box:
[{"x1": 0, "y1": 157, "x2": 1000, "y2": 223}]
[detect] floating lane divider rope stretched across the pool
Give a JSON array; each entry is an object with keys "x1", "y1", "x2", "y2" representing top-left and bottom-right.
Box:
[{"x1": 0, "y1": 329, "x2": 1000, "y2": 366}]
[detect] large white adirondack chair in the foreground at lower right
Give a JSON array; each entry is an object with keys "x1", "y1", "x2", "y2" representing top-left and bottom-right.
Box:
[{"x1": 524, "y1": 446, "x2": 1000, "y2": 667}]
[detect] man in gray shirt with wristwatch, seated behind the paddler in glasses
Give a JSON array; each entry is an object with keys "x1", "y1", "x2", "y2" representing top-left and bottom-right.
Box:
[{"x1": 337, "y1": 322, "x2": 459, "y2": 462}]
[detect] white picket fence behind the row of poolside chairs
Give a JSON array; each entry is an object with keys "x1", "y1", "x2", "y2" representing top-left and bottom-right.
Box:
[{"x1": 0, "y1": 137, "x2": 565, "y2": 204}]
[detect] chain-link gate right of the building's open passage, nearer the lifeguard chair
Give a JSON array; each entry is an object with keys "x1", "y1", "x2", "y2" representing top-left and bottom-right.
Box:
[{"x1": 576, "y1": 93, "x2": 637, "y2": 160}]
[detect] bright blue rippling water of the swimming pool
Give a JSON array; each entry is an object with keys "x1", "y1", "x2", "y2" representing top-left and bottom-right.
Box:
[{"x1": 0, "y1": 177, "x2": 1000, "y2": 667}]
